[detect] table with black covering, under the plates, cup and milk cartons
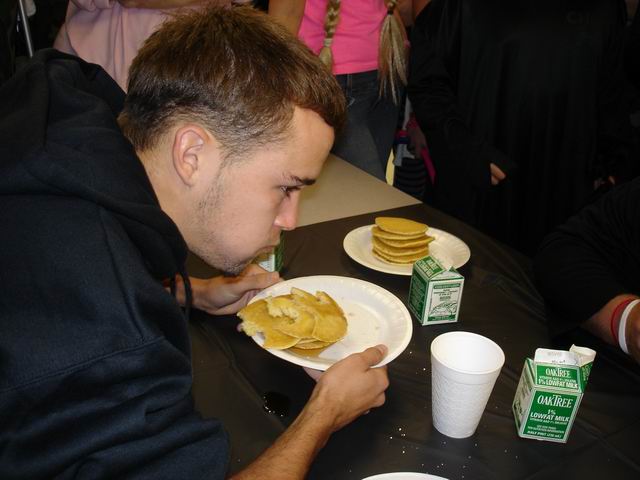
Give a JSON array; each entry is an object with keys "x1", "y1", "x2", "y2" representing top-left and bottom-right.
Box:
[{"x1": 185, "y1": 178, "x2": 640, "y2": 479}]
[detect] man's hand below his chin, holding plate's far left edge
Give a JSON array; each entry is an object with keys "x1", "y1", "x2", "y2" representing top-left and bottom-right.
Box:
[{"x1": 177, "y1": 264, "x2": 281, "y2": 315}]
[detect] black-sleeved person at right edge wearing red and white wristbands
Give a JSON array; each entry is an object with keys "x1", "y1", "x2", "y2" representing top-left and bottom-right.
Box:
[{"x1": 535, "y1": 177, "x2": 640, "y2": 362}]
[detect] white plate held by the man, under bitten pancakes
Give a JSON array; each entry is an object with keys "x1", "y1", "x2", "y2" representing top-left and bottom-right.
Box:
[{"x1": 251, "y1": 275, "x2": 413, "y2": 370}]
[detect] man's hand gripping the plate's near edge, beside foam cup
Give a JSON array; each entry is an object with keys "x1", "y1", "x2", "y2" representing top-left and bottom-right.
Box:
[{"x1": 307, "y1": 345, "x2": 389, "y2": 432}]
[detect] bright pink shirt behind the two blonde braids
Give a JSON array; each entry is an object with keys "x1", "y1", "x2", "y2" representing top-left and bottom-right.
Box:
[{"x1": 298, "y1": 0, "x2": 387, "y2": 75}]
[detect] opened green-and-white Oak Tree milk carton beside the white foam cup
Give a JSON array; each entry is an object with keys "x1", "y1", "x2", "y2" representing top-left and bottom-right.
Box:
[{"x1": 513, "y1": 345, "x2": 596, "y2": 443}]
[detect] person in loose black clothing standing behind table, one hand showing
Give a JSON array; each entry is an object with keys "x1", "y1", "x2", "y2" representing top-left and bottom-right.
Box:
[{"x1": 407, "y1": 0, "x2": 637, "y2": 255}]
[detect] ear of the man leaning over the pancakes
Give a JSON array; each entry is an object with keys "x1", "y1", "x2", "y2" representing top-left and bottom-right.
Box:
[{"x1": 171, "y1": 124, "x2": 216, "y2": 187}]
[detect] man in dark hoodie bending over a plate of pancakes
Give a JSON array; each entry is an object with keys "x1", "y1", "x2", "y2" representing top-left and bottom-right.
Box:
[{"x1": 0, "y1": 7, "x2": 388, "y2": 479}]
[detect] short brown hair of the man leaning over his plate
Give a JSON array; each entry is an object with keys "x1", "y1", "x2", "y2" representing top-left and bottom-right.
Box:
[{"x1": 119, "y1": 7, "x2": 345, "y2": 156}]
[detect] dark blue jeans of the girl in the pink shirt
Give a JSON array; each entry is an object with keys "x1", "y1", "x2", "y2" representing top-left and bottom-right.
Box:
[{"x1": 332, "y1": 70, "x2": 399, "y2": 180}]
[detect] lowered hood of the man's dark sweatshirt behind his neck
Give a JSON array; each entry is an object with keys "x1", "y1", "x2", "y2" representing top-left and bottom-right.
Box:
[{"x1": 0, "y1": 50, "x2": 187, "y2": 279}]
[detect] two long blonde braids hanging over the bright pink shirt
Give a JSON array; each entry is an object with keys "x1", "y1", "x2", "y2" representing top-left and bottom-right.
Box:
[{"x1": 318, "y1": 0, "x2": 407, "y2": 104}]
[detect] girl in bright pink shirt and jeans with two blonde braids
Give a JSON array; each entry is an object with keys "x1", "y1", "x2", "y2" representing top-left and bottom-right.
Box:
[{"x1": 269, "y1": 0, "x2": 407, "y2": 180}]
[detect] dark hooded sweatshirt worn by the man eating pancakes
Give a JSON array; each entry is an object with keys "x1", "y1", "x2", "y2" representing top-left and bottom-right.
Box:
[{"x1": 0, "y1": 50, "x2": 228, "y2": 480}]
